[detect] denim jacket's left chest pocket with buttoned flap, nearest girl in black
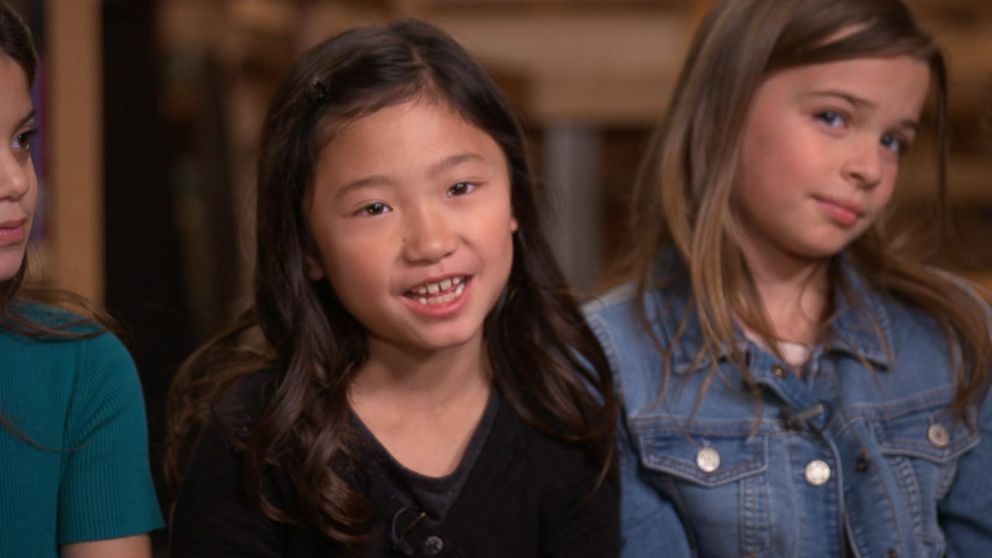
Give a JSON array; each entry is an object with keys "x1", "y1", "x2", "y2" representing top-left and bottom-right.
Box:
[{"x1": 632, "y1": 420, "x2": 771, "y2": 556}]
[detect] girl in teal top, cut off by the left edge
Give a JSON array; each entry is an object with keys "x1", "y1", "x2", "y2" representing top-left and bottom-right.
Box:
[{"x1": 0, "y1": 3, "x2": 162, "y2": 558}]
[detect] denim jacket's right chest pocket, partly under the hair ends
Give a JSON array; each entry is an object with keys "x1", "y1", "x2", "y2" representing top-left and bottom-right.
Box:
[{"x1": 871, "y1": 407, "x2": 979, "y2": 547}]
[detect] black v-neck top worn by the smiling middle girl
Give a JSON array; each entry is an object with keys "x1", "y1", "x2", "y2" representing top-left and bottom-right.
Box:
[{"x1": 172, "y1": 372, "x2": 620, "y2": 558}]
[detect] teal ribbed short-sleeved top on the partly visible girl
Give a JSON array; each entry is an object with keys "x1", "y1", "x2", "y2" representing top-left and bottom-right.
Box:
[{"x1": 0, "y1": 308, "x2": 162, "y2": 558}]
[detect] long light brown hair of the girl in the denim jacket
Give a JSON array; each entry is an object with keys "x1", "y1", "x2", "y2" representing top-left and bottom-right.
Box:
[{"x1": 625, "y1": 0, "x2": 992, "y2": 420}]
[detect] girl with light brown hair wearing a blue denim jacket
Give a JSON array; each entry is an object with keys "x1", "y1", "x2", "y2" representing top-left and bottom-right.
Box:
[{"x1": 587, "y1": 0, "x2": 992, "y2": 557}]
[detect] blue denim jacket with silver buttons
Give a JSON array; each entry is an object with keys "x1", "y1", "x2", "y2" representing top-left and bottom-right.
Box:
[{"x1": 586, "y1": 258, "x2": 992, "y2": 558}]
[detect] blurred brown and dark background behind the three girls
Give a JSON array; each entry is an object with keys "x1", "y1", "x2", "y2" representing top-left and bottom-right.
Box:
[{"x1": 8, "y1": 0, "x2": 992, "y2": 553}]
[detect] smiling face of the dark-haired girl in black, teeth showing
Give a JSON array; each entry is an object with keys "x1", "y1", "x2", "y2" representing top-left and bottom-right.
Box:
[{"x1": 305, "y1": 100, "x2": 517, "y2": 356}]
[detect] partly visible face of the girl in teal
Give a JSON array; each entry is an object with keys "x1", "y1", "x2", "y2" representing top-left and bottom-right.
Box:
[{"x1": 0, "y1": 53, "x2": 38, "y2": 281}]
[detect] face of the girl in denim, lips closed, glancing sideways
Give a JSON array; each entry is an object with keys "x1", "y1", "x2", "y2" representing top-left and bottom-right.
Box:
[{"x1": 733, "y1": 56, "x2": 930, "y2": 265}]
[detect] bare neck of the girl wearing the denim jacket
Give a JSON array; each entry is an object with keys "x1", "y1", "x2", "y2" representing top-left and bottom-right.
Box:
[{"x1": 740, "y1": 233, "x2": 829, "y2": 344}]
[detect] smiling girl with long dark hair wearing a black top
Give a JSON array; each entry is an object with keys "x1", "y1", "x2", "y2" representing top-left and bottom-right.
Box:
[{"x1": 168, "y1": 17, "x2": 618, "y2": 557}]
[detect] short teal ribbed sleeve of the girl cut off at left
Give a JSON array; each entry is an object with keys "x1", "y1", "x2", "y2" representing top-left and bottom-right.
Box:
[{"x1": 57, "y1": 333, "x2": 163, "y2": 545}]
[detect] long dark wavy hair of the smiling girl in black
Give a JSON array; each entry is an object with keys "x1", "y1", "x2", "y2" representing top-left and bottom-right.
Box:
[{"x1": 166, "y1": 20, "x2": 614, "y2": 542}]
